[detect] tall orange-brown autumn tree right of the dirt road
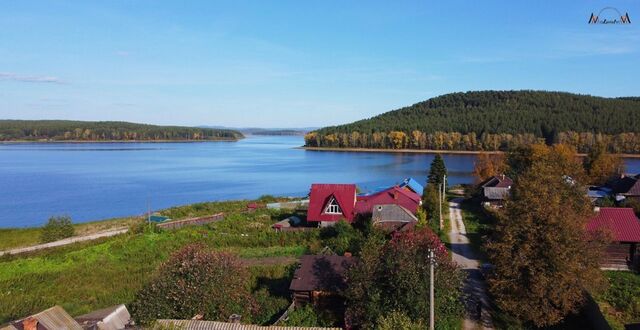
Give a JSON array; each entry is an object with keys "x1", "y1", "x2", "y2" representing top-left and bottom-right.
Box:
[{"x1": 487, "y1": 146, "x2": 605, "y2": 327}]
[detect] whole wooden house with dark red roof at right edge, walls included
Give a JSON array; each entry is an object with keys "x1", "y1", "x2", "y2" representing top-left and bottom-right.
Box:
[{"x1": 586, "y1": 207, "x2": 640, "y2": 269}]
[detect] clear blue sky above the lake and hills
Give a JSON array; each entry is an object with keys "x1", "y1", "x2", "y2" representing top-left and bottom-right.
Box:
[{"x1": 0, "y1": 0, "x2": 640, "y2": 127}]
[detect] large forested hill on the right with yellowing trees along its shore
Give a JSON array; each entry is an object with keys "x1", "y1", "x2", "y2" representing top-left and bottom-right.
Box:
[{"x1": 305, "y1": 91, "x2": 640, "y2": 153}]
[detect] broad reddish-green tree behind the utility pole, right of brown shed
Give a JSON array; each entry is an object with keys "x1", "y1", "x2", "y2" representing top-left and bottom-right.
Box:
[{"x1": 346, "y1": 228, "x2": 464, "y2": 329}]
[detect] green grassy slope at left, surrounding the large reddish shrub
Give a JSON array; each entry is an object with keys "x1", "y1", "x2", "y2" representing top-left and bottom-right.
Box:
[{"x1": 0, "y1": 201, "x2": 321, "y2": 324}]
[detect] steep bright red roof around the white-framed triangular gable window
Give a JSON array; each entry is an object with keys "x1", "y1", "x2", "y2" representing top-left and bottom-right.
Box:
[{"x1": 307, "y1": 183, "x2": 356, "y2": 222}]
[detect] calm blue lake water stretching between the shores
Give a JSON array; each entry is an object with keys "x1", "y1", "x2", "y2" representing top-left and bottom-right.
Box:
[{"x1": 0, "y1": 137, "x2": 640, "y2": 227}]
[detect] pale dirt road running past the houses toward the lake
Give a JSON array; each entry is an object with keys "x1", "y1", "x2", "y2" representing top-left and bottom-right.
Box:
[{"x1": 449, "y1": 198, "x2": 493, "y2": 329}]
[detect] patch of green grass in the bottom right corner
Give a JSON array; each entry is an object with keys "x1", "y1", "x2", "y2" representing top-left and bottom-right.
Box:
[{"x1": 594, "y1": 271, "x2": 640, "y2": 329}]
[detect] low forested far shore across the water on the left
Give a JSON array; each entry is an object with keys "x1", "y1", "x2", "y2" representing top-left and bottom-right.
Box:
[{"x1": 0, "y1": 120, "x2": 243, "y2": 141}]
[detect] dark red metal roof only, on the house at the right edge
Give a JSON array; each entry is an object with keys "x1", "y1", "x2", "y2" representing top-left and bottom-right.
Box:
[{"x1": 587, "y1": 207, "x2": 640, "y2": 242}]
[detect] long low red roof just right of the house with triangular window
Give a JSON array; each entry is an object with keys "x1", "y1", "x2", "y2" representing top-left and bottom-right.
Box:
[{"x1": 356, "y1": 186, "x2": 421, "y2": 214}]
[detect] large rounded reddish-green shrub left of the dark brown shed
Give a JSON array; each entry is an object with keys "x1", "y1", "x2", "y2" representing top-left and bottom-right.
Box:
[{"x1": 131, "y1": 244, "x2": 257, "y2": 325}]
